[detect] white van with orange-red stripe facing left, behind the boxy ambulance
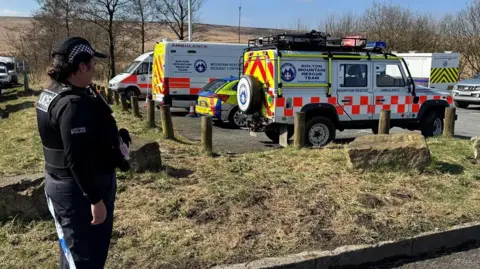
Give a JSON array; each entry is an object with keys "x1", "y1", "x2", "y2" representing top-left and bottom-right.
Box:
[{"x1": 108, "y1": 52, "x2": 153, "y2": 100}]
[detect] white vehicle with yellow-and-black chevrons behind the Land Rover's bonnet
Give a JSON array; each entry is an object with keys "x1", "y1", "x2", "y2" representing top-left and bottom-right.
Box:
[{"x1": 392, "y1": 51, "x2": 460, "y2": 90}]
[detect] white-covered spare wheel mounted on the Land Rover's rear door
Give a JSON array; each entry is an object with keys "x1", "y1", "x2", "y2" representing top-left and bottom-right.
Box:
[{"x1": 237, "y1": 75, "x2": 263, "y2": 114}]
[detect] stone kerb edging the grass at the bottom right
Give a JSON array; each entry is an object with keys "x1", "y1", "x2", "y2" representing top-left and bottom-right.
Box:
[{"x1": 213, "y1": 222, "x2": 480, "y2": 269}]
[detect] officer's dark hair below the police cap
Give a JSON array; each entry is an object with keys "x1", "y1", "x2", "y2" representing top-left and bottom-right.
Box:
[{"x1": 47, "y1": 52, "x2": 93, "y2": 83}]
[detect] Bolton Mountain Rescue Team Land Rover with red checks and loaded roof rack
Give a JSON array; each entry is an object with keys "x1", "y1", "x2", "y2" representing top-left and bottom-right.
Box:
[{"x1": 237, "y1": 31, "x2": 452, "y2": 147}]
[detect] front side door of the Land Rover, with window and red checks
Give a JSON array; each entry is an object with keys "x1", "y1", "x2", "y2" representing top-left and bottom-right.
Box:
[{"x1": 373, "y1": 60, "x2": 412, "y2": 120}]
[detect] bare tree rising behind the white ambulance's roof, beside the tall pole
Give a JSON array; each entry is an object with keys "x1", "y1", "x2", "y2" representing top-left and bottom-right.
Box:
[{"x1": 154, "y1": 0, "x2": 205, "y2": 40}]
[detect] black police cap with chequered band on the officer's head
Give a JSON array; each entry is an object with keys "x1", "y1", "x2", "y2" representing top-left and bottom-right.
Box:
[{"x1": 52, "y1": 36, "x2": 107, "y2": 63}]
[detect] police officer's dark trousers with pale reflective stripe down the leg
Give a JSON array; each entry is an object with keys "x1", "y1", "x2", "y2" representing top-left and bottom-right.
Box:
[{"x1": 45, "y1": 171, "x2": 117, "y2": 269}]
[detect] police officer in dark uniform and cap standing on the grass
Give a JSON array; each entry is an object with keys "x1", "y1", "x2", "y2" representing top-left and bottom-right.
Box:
[{"x1": 37, "y1": 37, "x2": 129, "y2": 269}]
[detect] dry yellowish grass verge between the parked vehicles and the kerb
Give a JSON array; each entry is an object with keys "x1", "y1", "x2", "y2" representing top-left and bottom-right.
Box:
[{"x1": 0, "y1": 90, "x2": 480, "y2": 268}]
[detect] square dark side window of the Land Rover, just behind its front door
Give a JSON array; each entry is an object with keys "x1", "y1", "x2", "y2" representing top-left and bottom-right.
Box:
[{"x1": 339, "y1": 64, "x2": 368, "y2": 88}]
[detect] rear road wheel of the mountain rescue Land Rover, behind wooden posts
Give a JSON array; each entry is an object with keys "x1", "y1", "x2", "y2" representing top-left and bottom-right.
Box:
[{"x1": 305, "y1": 117, "x2": 335, "y2": 147}]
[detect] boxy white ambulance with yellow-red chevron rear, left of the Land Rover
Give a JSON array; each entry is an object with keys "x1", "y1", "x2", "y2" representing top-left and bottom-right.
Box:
[{"x1": 152, "y1": 39, "x2": 248, "y2": 108}]
